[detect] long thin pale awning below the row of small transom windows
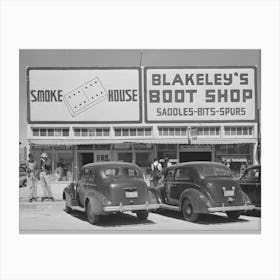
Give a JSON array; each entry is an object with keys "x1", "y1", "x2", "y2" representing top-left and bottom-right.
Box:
[{"x1": 29, "y1": 138, "x2": 258, "y2": 146}]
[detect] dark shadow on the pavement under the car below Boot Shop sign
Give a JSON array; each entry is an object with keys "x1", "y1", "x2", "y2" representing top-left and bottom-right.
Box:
[{"x1": 157, "y1": 209, "x2": 249, "y2": 225}]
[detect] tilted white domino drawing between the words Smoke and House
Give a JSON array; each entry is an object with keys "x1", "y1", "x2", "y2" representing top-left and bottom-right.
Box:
[{"x1": 63, "y1": 77, "x2": 108, "y2": 118}]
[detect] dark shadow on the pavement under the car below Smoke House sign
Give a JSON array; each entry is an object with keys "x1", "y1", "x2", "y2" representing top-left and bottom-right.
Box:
[{"x1": 64, "y1": 210, "x2": 154, "y2": 227}]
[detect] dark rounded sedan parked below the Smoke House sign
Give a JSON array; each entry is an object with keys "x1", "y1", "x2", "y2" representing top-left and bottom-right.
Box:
[{"x1": 63, "y1": 162, "x2": 159, "y2": 224}]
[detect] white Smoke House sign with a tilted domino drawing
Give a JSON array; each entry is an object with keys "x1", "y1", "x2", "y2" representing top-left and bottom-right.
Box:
[{"x1": 27, "y1": 67, "x2": 142, "y2": 123}]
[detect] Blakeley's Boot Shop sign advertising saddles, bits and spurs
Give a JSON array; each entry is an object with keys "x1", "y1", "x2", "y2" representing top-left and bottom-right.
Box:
[{"x1": 144, "y1": 66, "x2": 257, "y2": 123}]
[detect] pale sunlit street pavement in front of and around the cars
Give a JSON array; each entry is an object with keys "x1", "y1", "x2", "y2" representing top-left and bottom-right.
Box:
[{"x1": 19, "y1": 199, "x2": 261, "y2": 233}]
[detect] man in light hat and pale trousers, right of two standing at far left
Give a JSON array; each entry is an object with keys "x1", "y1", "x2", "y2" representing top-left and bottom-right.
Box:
[{"x1": 40, "y1": 153, "x2": 54, "y2": 201}]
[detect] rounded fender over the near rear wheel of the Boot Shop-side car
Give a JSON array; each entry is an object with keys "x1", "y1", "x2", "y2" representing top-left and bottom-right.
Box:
[{"x1": 179, "y1": 188, "x2": 212, "y2": 213}]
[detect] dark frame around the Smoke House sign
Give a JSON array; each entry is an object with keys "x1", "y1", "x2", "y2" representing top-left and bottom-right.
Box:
[{"x1": 26, "y1": 66, "x2": 143, "y2": 124}]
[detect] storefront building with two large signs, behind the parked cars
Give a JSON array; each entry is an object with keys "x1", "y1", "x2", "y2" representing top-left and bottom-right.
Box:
[{"x1": 27, "y1": 57, "x2": 259, "y2": 181}]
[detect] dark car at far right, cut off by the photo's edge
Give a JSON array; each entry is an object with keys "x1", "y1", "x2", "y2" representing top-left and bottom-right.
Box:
[{"x1": 239, "y1": 165, "x2": 261, "y2": 210}]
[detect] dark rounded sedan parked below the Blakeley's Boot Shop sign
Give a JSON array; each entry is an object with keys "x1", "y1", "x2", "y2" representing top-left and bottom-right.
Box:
[{"x1": 154, "y1": 162, "x2": 254, "y2": 222}]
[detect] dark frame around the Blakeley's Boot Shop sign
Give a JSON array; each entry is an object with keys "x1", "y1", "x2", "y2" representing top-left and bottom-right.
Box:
[{"x1": 143, "y1": 65, "x2": 258, "y2": 123}]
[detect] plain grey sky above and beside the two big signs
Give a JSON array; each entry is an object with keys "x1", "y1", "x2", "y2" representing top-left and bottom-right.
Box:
[{"x1": 19, "y1": 49, "x2": 261, "y2": 146}]
